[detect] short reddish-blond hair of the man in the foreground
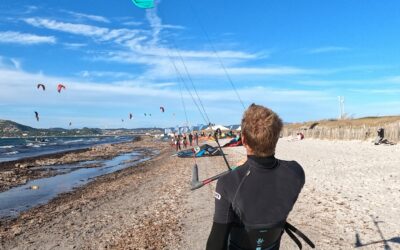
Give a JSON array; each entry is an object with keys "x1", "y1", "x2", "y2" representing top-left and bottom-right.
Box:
[{"x1": 242, "y1": 103, "x2": 283, "y2": 156}]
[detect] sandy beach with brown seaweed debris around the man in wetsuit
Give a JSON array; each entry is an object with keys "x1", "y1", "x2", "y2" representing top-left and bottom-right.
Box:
[{"x1": 0, "y1": 138, "x2": 400, "y2": 249}]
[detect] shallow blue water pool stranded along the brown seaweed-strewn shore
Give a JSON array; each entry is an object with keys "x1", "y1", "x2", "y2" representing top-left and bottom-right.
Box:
[{"x1": 0, "y1": 152, "x2": 155, "y2": 218}]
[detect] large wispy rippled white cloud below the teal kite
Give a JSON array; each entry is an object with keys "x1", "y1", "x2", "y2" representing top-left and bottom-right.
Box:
[{"x1": 25, "y1": 14, "x2": 272, "y2": 80}]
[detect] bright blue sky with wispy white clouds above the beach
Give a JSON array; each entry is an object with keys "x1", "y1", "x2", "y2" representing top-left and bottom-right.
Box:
[{"x1": 0, "y1": 0, "x2": 400, "y2": 128}]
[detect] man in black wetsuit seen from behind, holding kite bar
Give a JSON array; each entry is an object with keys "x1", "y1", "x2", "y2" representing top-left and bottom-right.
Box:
[{"x1": 207, "y1": 104, "x2": 304, "y2": 250}]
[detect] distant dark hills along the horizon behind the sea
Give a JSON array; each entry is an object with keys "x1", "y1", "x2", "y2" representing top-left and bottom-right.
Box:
[{"x1": 0, "y1": 120, "x2": 164, "y2": 137}]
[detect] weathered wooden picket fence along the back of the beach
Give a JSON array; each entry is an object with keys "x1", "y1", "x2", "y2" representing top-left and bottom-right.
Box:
[{"x1": 282, "y1": 123, "x2": 400, "y2": 142}]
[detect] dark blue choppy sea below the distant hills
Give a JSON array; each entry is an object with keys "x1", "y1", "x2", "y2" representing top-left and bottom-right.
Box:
[{"x1": 0, "y1": 136, "x2": 134, "y2": 162}]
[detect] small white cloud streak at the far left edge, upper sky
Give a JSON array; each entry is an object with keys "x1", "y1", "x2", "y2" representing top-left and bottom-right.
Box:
[{"x1": 0, "y1": 31, "x2": 56, "y2": 45}]
